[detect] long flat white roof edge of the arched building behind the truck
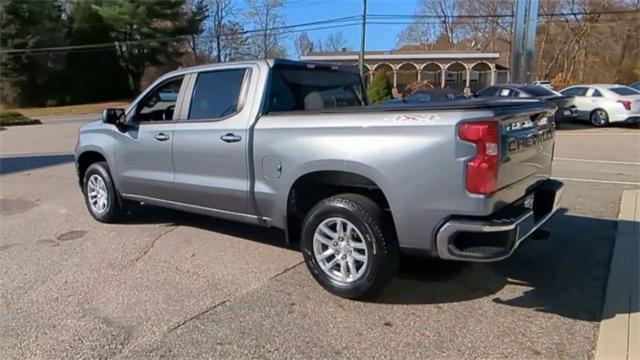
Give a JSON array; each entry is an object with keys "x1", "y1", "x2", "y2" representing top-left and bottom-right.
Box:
[{"x1": 300, "y1": 50, "x2": 500, "y2": 61}]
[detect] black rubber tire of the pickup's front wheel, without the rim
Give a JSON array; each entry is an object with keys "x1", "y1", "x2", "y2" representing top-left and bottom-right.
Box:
[{"x1": 82, "y1": 161, "x2": 126, "y2": 223}]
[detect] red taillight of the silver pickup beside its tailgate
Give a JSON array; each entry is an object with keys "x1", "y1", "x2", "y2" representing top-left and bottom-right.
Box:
[{"x1": 458, "y1": 121, "x2": 499, "y2": 194}]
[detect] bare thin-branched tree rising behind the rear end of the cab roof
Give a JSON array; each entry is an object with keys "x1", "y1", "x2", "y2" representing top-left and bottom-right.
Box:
[{"x1": 245, "y1": 0, "x2": 286, "y2": 59}]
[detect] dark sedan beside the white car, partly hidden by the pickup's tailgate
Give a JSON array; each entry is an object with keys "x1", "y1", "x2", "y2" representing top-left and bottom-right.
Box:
[{"x1": 474, "y1": 84, "x2": 578, "y2": 120}]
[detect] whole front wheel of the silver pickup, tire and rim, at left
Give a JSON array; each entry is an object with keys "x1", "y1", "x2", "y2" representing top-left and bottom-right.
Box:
[{"x1": 82, "y1": 161, "x2": 125, "y2": 223}]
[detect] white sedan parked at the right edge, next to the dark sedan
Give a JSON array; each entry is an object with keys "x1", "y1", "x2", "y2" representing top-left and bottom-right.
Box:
[{"x1": 560, "y1": 84, "x2": 640, "y2": 126}]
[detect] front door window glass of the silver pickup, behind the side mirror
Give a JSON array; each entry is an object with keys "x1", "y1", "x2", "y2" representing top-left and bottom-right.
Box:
[{"x1": 136, "y1": 76, "x2": 183, "y2": 122}]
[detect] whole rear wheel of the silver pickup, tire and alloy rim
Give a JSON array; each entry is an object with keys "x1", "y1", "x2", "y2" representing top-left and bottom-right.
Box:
[{"x1": 301, "y1": 194, "x2": 399, "y2": 298}]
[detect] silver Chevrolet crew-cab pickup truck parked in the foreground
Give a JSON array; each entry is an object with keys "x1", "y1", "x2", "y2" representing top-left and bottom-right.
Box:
[{"x1": 75, "y1": 60, "x2": 562, "y2": 298}]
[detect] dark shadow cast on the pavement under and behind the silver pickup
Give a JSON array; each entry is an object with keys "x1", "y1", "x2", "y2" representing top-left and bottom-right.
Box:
[{"x1": 121, "y1": 207, "x2": 624, "y2": 321}]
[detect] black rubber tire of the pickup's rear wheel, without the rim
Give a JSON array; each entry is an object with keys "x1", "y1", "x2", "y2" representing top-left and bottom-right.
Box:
[{"x1": 301, "y1": 194, "x2": 399, "y2": 299}]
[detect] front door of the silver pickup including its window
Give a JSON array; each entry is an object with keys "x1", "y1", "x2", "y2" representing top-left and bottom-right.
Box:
[{"x1": 114, "y1": 76, "x2": 186, "y2": 200}]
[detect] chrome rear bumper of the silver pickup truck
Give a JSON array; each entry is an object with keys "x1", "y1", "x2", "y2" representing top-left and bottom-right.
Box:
[{"x1": 436, "y1": 180, "x2": 564, "y2": 262}]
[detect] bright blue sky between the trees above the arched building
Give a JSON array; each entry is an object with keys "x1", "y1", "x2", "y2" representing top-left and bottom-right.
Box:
[{"x1": 238, "y1": 0, "x2": 418, "y2": 57}]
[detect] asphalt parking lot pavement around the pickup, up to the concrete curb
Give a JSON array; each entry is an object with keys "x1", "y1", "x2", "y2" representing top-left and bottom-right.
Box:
[{"x1": 0, "y1": 119, "x2": 640, "y2": 359}]
